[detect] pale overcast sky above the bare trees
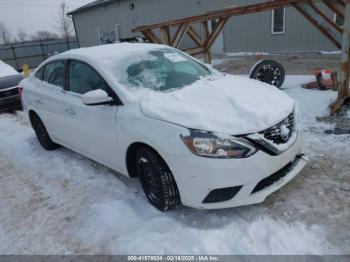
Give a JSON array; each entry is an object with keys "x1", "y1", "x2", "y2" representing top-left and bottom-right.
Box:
[{"x1": 0, "y1": 0, "x2": 93, "y2": 36}]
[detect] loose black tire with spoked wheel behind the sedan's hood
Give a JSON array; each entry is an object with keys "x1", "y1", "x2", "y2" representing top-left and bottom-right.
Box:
[{"x1": 250, "y1": 60, "x2": 286, "y2": 88}]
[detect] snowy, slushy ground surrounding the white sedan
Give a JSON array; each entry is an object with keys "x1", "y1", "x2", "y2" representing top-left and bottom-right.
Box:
[{"x1": 0, "y1": 76, "x2": 350, "y2": 254}]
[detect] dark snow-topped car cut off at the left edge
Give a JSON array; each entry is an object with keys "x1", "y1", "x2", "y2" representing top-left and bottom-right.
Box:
[{"x1": 0, "y1": 60, "x2": 23, "y2": 112}]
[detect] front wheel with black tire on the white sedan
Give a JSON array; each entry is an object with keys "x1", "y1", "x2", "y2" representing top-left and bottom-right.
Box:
[{"x1": 136, "y1": 147, "x2": 181, "y2": 211}]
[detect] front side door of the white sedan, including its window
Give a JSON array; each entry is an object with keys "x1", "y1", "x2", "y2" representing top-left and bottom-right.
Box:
[{"x1": 64, "y1": 60, "x2": 118, "y2": 168}]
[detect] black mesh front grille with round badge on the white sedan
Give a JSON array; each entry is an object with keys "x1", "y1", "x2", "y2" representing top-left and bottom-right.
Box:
[{"x1": 260, "y1": 113, "x2": 295, "y2": 145}]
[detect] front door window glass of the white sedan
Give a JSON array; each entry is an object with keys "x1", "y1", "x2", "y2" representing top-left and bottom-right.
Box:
[{"x1": 69, "y1": 61, "x2": 108, "y2": 95}]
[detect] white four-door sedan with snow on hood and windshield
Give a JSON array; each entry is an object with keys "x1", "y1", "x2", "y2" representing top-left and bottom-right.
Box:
[{"x1": 21, "y1": 43, "x2": 307, "y2": 210}]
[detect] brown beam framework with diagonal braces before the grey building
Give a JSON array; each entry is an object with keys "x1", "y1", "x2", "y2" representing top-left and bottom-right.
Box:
[{"x1": 132, "y1": 0, "x2": 350, "y2": 114}]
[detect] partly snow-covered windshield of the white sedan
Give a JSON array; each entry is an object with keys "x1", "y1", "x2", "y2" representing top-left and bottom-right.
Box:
[{"x1": 121, "y1": 48, "x2": 211, "y2": 91}]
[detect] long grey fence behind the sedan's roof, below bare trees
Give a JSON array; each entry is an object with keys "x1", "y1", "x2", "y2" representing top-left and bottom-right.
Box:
[{"x1": 0, "y1": 38, "x2": 79, "y2": 71}]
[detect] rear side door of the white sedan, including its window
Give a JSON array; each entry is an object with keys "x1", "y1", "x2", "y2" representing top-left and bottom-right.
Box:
[{"x1": 33, "y1": 60, "x2": 66, "y2": 142}]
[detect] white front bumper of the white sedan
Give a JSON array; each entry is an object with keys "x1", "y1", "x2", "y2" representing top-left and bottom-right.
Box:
[{"x1": 166, "y1": 132, "x2": 308, "y2": 209}]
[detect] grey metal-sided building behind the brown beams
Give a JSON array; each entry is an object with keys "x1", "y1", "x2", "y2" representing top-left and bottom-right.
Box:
[{"x1": 69, "y1": 0, "x2": 342, "y2": 53}]
